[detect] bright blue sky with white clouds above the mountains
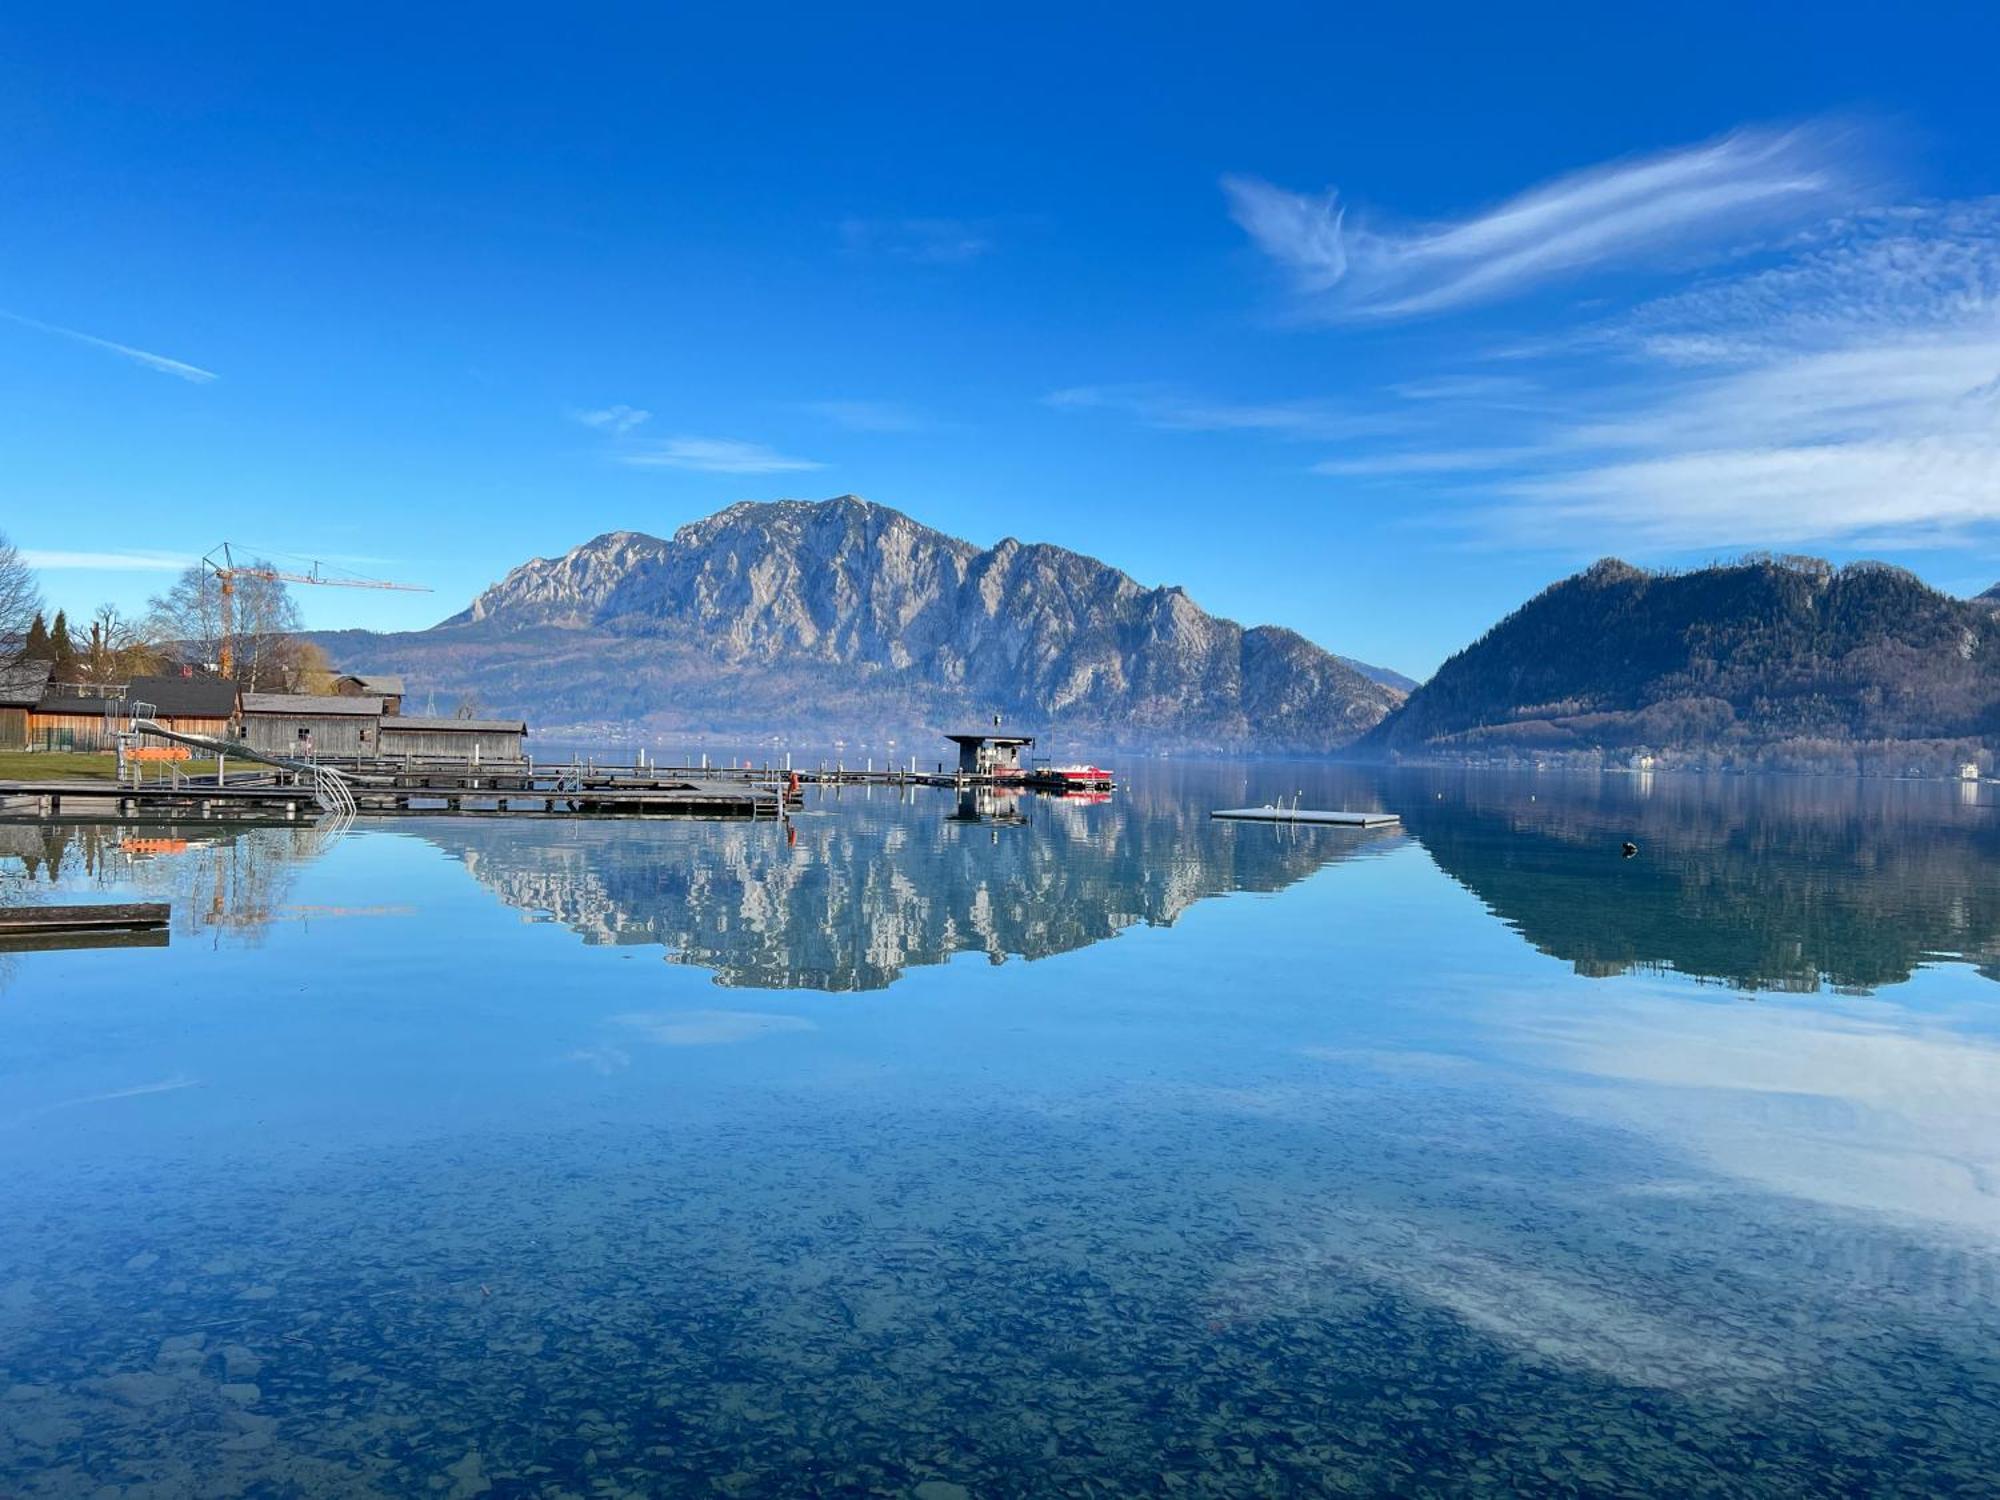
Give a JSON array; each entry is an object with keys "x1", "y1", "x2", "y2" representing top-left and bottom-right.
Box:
[{"x1": 0, "y1": 4, "x2": 2000, "y2": 674}]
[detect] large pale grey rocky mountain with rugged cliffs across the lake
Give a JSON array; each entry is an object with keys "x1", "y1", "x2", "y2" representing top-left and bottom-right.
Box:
[{"x1": 320, "y1": 496, "x2": 1402, "y2": 752}]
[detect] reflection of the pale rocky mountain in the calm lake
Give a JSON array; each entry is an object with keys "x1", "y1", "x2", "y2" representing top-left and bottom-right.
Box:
[{"x1": 406, "y1": 778, "x2": 1404, "y2": 990}]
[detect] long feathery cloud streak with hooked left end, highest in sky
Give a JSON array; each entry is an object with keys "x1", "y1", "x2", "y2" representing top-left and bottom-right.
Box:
[{"x1": 1222, "y1": 124, "x2": 1862, "y2": 318}]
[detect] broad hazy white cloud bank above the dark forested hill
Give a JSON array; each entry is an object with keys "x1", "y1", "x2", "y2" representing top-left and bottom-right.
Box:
[{"x1": 1494, "y1": 202, "x2": 2000, "y2": 548}]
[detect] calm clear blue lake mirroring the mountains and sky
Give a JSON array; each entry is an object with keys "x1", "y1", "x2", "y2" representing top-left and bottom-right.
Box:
[{"x1": 0, "y1": 766, "x2": 2000, "y2": 1500}]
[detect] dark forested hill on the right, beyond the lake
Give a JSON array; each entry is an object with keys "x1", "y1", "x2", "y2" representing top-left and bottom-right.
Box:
[{"x1": 1356, "y1": 558, "x2": 2000, "y2": 776}]
